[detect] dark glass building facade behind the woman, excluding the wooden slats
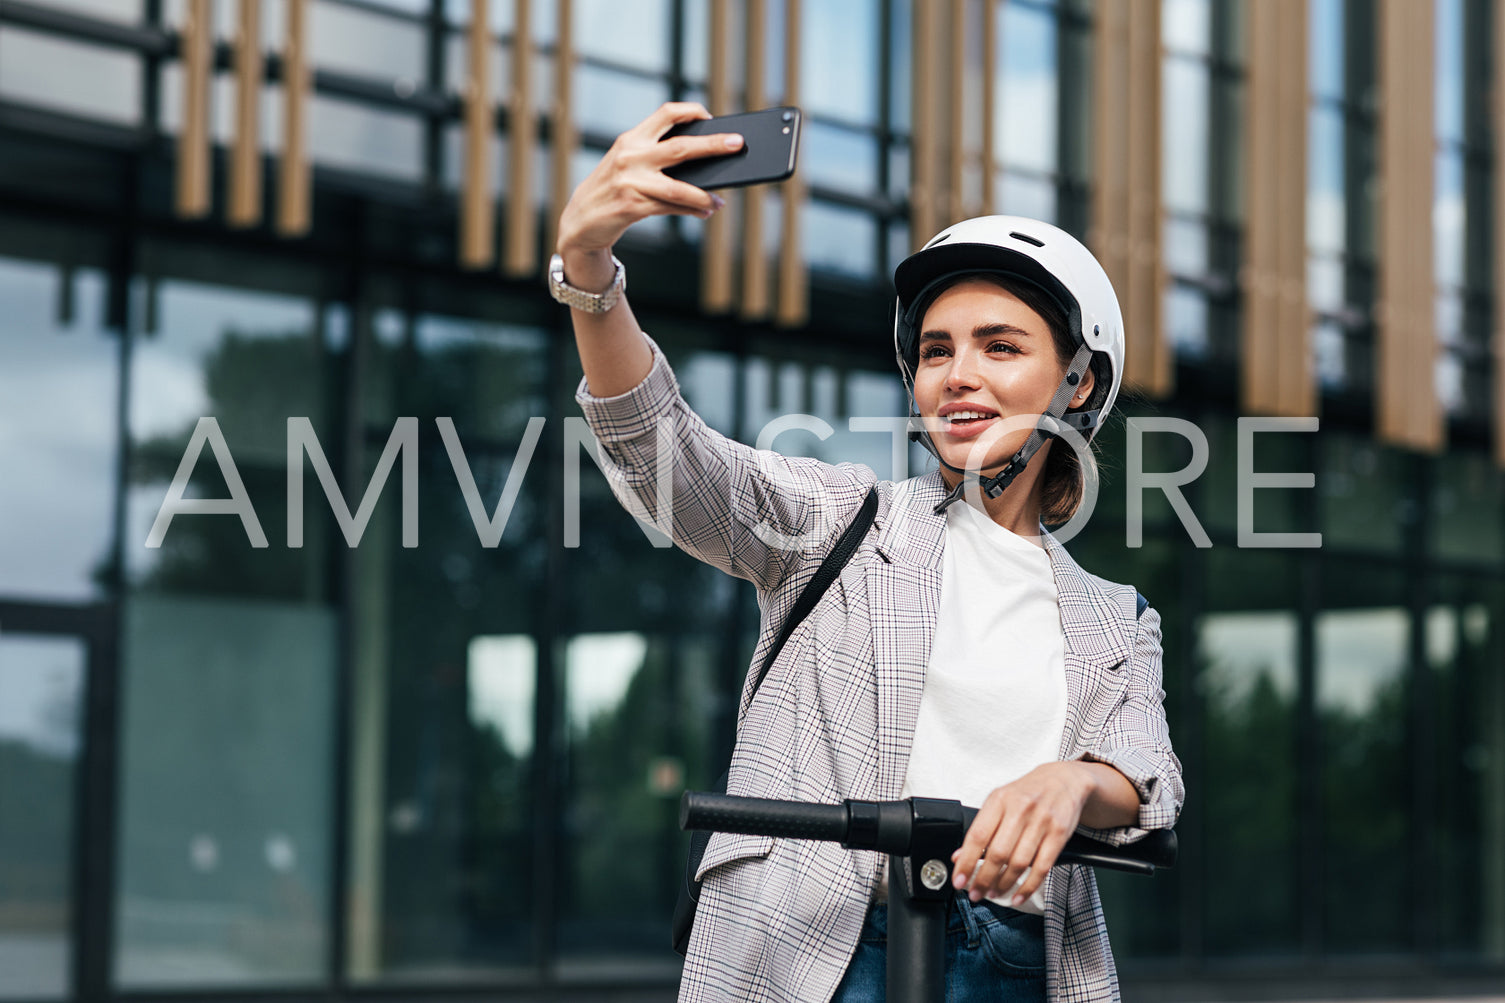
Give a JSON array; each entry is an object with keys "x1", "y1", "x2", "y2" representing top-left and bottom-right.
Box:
[{"x1": 0, "y1": 0, "x2": 1505, "y2": 1003}]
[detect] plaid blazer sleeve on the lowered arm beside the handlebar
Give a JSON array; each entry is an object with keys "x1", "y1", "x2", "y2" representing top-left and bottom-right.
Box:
[{"x1": 1082, "y1": 608, "x2": 1186, "y2": 846}]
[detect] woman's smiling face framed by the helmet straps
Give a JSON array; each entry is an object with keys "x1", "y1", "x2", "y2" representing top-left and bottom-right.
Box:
[{"x1": 915, "y1": 279, "x2": 1093, "y2": 480}]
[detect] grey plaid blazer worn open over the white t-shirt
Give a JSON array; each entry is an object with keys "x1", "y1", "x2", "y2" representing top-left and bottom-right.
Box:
[{"x1": 576, "y1": 337, "x2": 1184, "y2": 1003}]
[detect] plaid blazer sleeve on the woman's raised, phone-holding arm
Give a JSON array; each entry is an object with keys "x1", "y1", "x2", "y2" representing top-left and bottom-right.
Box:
[{"x1": 575, "y1": 339, "x2": 877, "y2": 592}]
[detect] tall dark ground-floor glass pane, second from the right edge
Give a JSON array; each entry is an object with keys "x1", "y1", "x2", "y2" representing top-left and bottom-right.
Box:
[{"x1": 1312, "y1": 562, "x2": 1408, "y2": 955}]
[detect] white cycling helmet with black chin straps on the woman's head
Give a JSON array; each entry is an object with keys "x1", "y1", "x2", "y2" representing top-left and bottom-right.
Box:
[{"x1": 894, "y1": 215, "x2": 1124, "y2": 509}]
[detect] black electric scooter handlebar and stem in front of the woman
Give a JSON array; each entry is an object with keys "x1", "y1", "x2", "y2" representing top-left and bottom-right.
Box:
[{"x1": 679, "y1": 791, "x2": 1177, "y2": 1003}]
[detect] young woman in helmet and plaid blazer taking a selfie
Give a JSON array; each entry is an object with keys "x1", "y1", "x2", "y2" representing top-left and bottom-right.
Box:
[{"x1": 551, "y1": 104, "x2": 1183, "y2": 1001}]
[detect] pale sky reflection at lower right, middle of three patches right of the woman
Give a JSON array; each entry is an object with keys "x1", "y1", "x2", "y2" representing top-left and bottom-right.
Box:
[{"x1": 1317, "y1": 608, "x2": 1409, "y2": 715}]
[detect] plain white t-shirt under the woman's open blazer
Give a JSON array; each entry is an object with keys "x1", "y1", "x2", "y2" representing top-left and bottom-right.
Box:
[{"x1": 901, "y1": 502, "x2": 1067, "y2": 914}]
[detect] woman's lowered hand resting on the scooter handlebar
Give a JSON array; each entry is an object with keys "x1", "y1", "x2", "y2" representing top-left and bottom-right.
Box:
[{"x1": 951, "y1": 762, "x2": 1113, "y2": 905}]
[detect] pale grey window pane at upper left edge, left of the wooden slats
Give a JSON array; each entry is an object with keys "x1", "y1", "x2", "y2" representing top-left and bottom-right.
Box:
[{"x1": 0, "y1": 27, "x2": 141, "y2": 125}]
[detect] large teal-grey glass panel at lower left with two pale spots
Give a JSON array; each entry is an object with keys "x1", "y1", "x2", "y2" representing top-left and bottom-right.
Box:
[{"x1": 113, "y1": 595, "x2": 337, "y2": 989}]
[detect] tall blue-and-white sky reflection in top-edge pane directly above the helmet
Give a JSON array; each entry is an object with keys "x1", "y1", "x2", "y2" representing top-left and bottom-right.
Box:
[{"x1": 993, "y1": 3, "x2": 1060, "y2": 173}]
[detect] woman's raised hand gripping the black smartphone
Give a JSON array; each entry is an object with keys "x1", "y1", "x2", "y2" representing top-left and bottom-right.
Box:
[{"x1": 558, "y1": 101, "x2": 742, "y2": 262}]
